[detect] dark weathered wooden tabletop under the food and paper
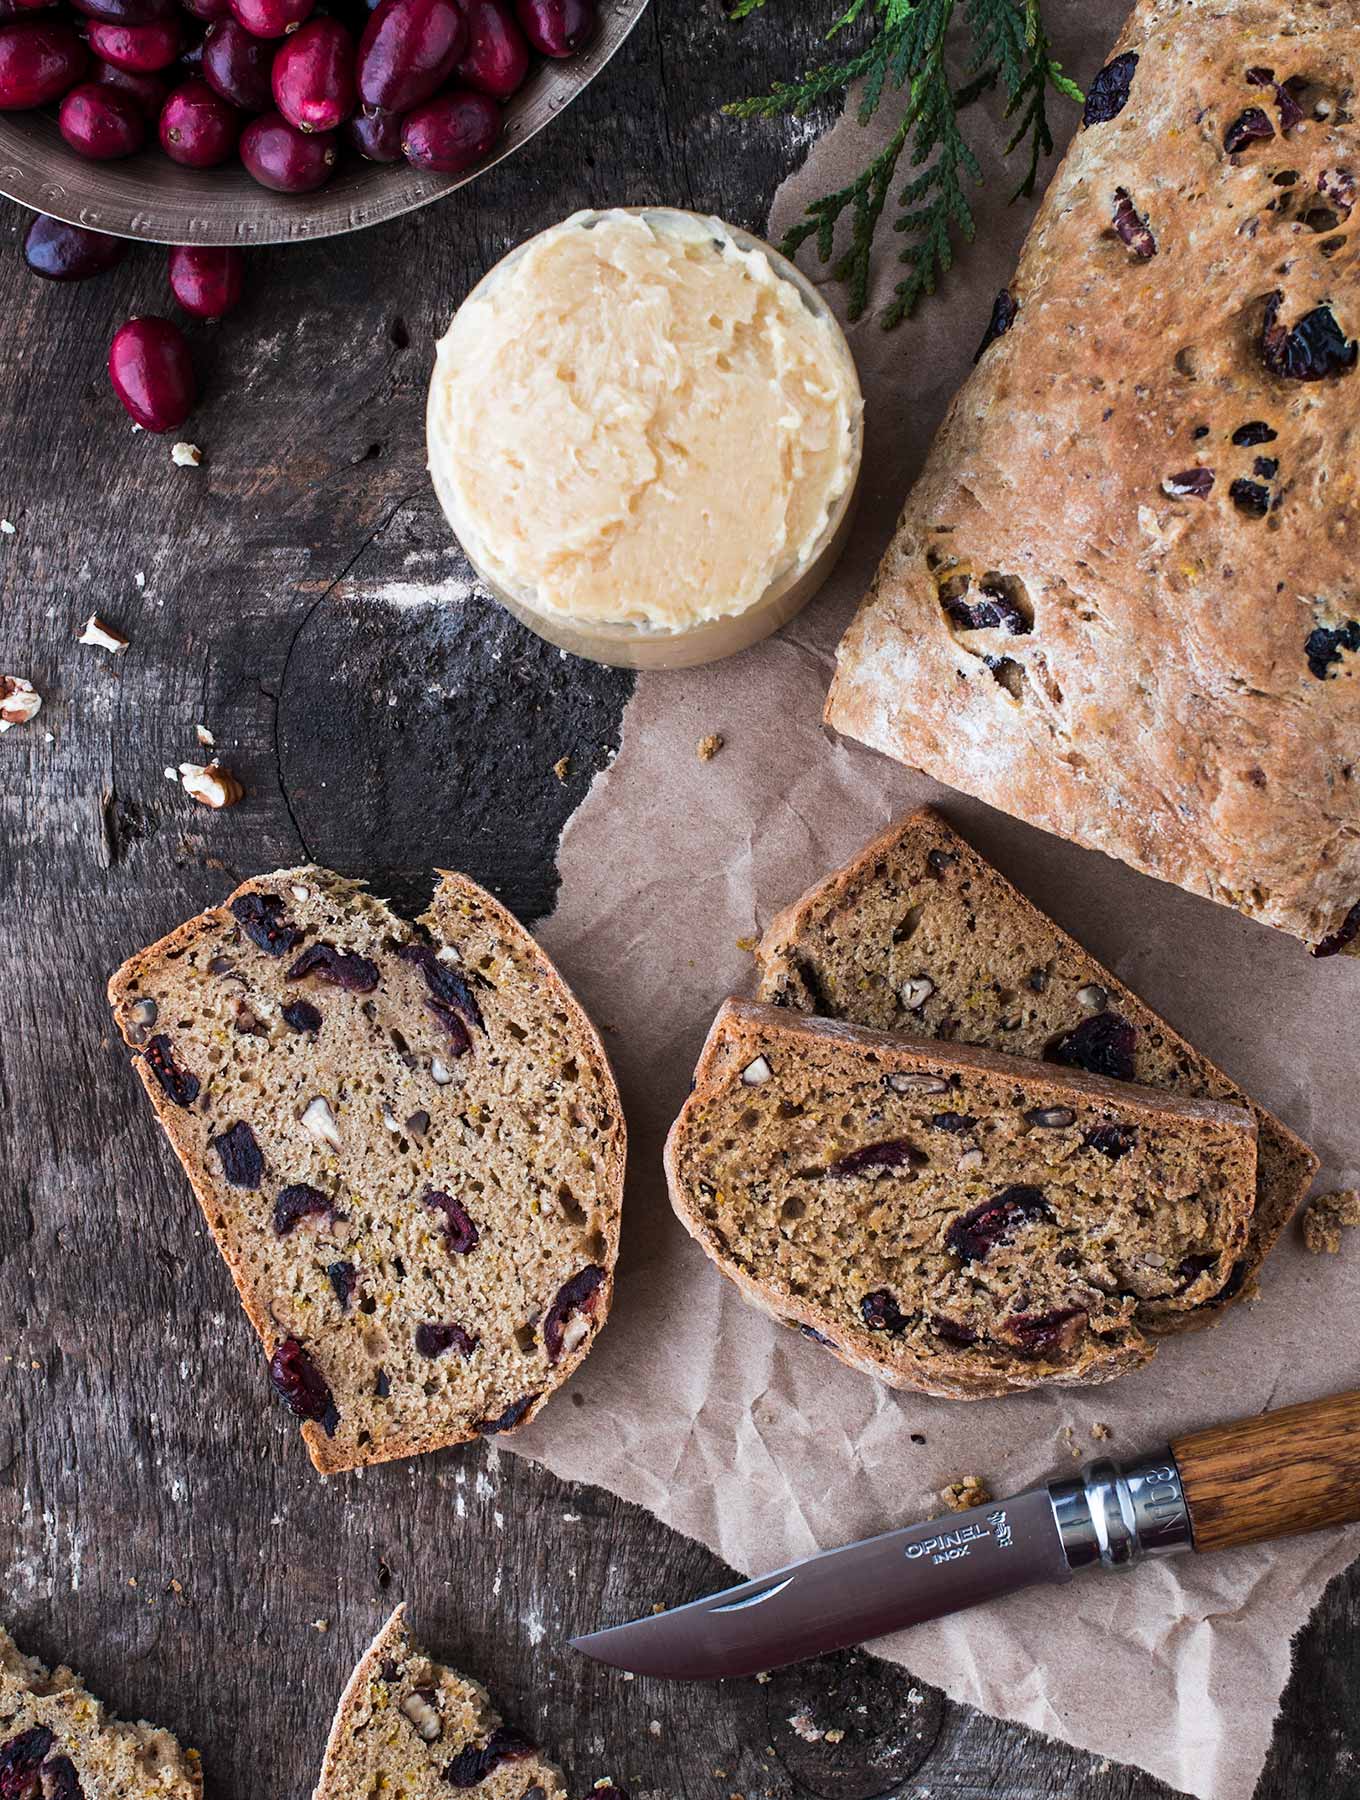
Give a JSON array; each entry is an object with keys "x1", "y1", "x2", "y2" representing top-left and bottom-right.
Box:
[{"x1": 0, "y1": 0, "x2": 1360, "y2": 1800}]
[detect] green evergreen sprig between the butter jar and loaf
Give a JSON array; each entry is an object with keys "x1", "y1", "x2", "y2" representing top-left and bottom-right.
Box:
[{"x1": 727, "y1": 0, "x2": 1081, "y2": 328}]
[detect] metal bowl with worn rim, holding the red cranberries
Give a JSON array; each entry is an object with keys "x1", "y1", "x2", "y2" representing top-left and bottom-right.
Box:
[{"x1": 0, "y1": 0, "x2": 648, "y2": 245}]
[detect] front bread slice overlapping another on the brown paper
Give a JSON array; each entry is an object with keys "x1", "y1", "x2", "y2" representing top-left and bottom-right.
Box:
[{"x1": 666, "y1": 1001, "x2": 1256, "y2": 1399}]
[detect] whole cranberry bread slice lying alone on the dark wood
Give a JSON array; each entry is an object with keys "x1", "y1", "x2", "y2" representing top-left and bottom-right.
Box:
[{"x1": 110, "y1": 868, "x2": 624, "y2": 1471}]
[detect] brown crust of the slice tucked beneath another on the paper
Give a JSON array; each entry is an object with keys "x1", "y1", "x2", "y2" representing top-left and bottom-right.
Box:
[{"x1": 756, "y1": 806, "x2": 1319, "y2": 1332}]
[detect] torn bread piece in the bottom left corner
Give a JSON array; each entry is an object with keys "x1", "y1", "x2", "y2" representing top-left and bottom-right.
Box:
[{"x1": 0, "y1": 1625, "x2": 203, "y2": 1800}]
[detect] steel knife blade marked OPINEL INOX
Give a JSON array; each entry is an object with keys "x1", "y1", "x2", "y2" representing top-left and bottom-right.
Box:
[{"x1": 572, "y1": 1489, "x2": 1072, "y2": 1681}]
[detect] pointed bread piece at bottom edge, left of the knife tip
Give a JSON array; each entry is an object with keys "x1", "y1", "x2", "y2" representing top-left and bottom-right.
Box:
[{"x1": 313, "y1": 1606, "x2": 565, "y2": 1800}]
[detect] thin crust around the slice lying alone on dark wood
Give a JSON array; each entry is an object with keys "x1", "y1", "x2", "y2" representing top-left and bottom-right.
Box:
[{"x1": 108, "y1": 864, "x2": 628, "y2": 1474}]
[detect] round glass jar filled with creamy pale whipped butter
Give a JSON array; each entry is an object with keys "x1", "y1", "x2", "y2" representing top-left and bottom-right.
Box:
[{"x1": 428, "y1": 209, "x2": 862, "y2": 664}]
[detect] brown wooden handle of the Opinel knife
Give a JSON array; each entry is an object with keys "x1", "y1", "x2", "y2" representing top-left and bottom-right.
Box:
[{"x1": 1171, "y1": 1390, "x2": 1360, "y2": 1550}]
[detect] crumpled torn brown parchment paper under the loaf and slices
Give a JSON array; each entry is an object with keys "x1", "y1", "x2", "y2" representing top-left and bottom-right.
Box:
[{"x1": 509, "y1": 0, "x2": 1360, "y2": 1800}]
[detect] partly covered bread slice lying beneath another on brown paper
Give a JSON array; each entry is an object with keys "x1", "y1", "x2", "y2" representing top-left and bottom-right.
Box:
[{"x1": 756, "y1": 806, "x2": 1317, "y2": 1330}]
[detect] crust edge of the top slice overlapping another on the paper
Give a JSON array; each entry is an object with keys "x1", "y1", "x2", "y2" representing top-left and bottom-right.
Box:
[{"x1": 666, "y1": 997, "x2": 1256, "y2": 1400}]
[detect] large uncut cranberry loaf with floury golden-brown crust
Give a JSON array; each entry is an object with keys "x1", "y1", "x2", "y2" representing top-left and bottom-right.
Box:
[{"x1": 826, "y1": 0, "x2": 1360, "y2": 956}]
